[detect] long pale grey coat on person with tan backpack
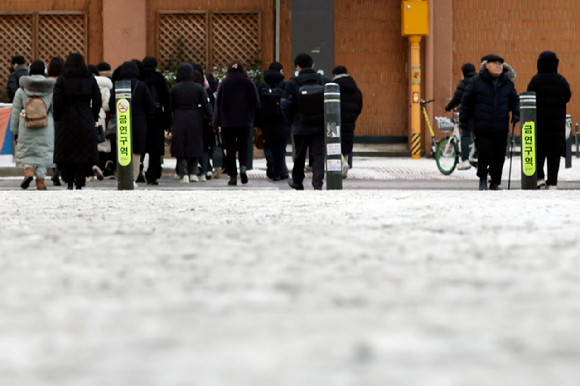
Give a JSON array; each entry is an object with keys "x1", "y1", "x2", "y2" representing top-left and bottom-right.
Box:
[{"x1": 10, "y1": 75, "x2": 56, "y2": 167}]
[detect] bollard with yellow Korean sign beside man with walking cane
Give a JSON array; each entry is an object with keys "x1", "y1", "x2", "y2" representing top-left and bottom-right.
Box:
[{"x1": 520, "y1": 91, "x2": 538, "y2": 190}]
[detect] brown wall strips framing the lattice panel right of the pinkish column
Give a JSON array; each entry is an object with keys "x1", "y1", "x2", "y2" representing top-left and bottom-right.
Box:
[{"x1": 147, "y1": 0, "x2": 292, "y2": 74}]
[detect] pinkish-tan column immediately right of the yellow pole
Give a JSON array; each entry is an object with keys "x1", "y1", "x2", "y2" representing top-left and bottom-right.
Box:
[{"x1": 423, "y1": 0, "x2": 460, "y2": 154}]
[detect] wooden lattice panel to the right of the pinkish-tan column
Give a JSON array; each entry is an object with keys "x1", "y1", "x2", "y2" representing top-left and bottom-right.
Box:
[{"x1": 156, "y1": 11, "x2": 262, "y2": 70}]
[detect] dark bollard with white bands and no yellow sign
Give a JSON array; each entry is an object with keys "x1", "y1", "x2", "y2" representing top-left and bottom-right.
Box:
[{"x1": 324, "y1": 83, "x2": 342, "y2": 190}]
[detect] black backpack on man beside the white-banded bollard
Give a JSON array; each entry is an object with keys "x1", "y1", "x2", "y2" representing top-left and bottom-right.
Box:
[{"x1": 297, "y1": 76, "x2": 324, "y2": 125}]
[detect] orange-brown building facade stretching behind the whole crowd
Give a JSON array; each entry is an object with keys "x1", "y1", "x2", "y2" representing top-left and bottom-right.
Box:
[{"x1": 0, "y1": 0, "x2": 580, "y2": 150}]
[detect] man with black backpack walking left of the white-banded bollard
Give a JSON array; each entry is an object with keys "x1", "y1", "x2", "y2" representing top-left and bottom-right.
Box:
[{"x1": 281, "y1": 54, "x2": 330, "y2": 190}]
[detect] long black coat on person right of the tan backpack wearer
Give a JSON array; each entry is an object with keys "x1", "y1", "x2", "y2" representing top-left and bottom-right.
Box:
[{"x1": 53, "y1": 70, "x2": 102, "y2": 165}]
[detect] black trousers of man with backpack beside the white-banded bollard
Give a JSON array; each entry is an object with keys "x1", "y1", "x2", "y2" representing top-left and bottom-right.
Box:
[{"x1": 292, "y1": 133, "x2": 325, "y2": 189}]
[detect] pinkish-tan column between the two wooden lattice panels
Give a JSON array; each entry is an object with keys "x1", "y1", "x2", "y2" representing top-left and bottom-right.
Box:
[{"x1": 103, "y1": 0, "x2": 148, "y2": 70}]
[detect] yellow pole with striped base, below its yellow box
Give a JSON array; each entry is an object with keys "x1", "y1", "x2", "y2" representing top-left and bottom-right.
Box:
[{"x1": 409, "y1": 35, "x2": 421, "y2": 159}]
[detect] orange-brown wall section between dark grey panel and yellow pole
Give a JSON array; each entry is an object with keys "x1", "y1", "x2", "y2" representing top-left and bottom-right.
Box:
[{"x1": 335, "y1": 0, "x2": 408, "y2": 136}]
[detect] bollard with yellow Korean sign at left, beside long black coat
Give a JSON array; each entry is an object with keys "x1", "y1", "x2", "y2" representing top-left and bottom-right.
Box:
[{"x1": 115, "y1": 80, "x2": 134, "y2": 190}]
